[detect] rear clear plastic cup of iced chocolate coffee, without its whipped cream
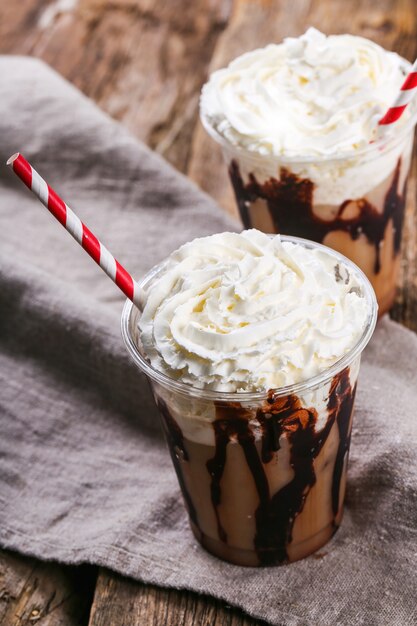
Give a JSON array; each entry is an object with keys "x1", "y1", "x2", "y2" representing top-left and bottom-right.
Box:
[{"x1": 202, "y1": 104, "x2": 417, "y2": 315}]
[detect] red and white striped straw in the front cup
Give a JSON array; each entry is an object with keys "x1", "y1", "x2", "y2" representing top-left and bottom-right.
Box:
[{"x1": 7, "y1": 153, "x2": 141, "y2": 307}]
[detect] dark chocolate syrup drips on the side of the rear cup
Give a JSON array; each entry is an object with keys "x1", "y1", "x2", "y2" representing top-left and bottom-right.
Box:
[{"x1": 229, "y1": 159, "x2": 406, "y2": 274}]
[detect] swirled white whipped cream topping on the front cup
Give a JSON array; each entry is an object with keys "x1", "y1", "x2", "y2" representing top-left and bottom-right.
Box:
[{"x1": 139, "y1": 230, "x2": 368, "y2": 392}]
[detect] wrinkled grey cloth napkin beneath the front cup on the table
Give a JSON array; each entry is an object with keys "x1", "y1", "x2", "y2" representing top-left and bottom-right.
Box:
[{"x1": 0, "y1": 57, "x2": 417, "y2": 626}]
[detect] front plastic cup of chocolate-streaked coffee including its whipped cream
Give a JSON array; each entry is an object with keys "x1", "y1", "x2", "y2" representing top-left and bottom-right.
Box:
[{"x1": 122, "y1": 229, "x2": 377, "y2": 566}]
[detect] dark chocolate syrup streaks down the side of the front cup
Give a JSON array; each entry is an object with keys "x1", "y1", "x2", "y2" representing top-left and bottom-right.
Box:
[{"x1": 158, "y1": 368, "x2": 356, "y2": 565}]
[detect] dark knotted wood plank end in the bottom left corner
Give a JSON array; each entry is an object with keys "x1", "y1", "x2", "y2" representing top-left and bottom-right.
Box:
[{"x1": 0, "y1": 551, "x2": 96, "y2": 626}]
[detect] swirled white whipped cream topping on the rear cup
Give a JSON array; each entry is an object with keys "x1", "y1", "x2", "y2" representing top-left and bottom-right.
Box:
[{"x1": 200, "y1": 28, "x2": 410, "y2": 157}]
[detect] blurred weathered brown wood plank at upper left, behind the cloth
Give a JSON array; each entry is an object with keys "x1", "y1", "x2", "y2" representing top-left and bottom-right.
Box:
[{"x1": 0, "y1": 0, "x2": 231, "y2": 171}]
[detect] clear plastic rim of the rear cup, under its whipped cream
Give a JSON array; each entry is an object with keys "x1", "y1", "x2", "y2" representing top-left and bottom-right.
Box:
[{"x1": 200, "y1": 94, "x2": 417, "y2": 166}]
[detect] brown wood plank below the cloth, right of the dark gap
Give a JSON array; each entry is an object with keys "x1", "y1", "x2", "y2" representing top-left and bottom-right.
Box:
[{"x1": 89, "y1": 570, "x2": 265, "y2": 626}]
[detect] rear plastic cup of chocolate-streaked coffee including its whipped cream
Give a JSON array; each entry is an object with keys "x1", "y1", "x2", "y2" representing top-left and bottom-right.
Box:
[{"x1": 201, "y1": 28, "x2": 417, "y2": 315}]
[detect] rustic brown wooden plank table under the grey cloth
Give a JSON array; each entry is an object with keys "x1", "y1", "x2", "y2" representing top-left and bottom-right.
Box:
[{"x1": 0, "y1": 0, "x2": 417, "y2": 626}]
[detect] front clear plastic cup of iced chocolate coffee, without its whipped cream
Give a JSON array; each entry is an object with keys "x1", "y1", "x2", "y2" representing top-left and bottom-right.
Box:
[{"x1": 122, "y1": 237, "x2": 377, "y2": 566}]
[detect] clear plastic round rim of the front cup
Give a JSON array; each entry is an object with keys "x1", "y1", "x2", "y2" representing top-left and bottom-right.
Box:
[{"x1": 121, "y1": 235, "x2": 378, "y2": 403}]
